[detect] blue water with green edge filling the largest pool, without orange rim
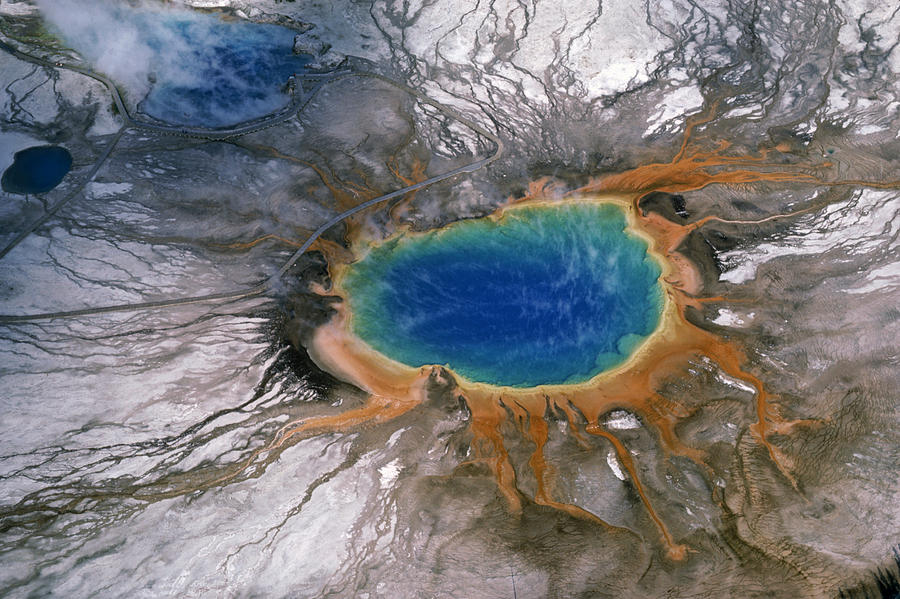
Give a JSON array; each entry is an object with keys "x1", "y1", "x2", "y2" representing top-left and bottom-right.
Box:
[{"x1": 343, "y1": 203, "x2": 663, "y2": 387}]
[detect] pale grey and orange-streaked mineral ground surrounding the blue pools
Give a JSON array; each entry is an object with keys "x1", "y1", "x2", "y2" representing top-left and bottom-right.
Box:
[{"x1": 0, "y1": 0, "x2": 900, "y2": 599}]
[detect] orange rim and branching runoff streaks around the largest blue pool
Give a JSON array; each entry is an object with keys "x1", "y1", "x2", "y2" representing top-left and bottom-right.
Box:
[{"x1": 284, "y1": 105, "x2": 900, "y2": 559}]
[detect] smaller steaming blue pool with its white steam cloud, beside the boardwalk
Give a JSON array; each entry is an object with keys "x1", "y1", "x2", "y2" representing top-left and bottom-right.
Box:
[{"x1": 36, "y1": 0, "x2": 303, "y2": 126}]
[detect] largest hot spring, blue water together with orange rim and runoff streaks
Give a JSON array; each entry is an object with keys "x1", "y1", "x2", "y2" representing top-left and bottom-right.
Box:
[{"x1": 304, "y1": 139, "x2": 844, "y2": 560}]
